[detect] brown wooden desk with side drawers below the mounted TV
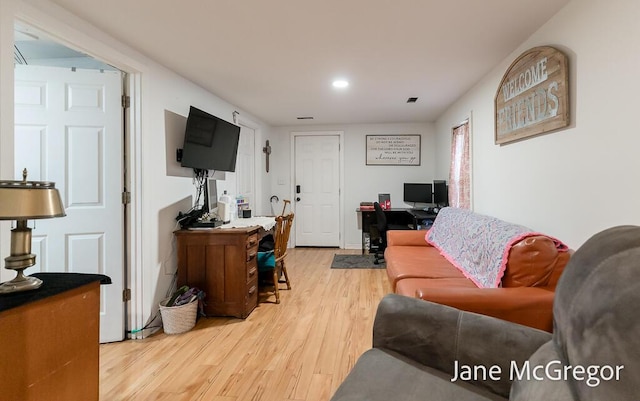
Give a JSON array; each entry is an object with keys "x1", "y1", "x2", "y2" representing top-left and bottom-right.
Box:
[{"x1": 174, "y1": 217, "x2": 275, "y2": 319}]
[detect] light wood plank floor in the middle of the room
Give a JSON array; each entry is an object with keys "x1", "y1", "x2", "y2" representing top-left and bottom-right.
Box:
[{"x1": 100, "y1": 248, "x2": 390, "y2": 401}]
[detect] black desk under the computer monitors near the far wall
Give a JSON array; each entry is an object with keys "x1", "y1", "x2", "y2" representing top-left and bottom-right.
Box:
[{"x1": 356, "y1": 208, "x2": 436, "y2": 254}]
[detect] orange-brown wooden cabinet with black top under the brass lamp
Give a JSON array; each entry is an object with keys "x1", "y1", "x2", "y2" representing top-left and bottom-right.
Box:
[{"x1": 0, "y1": 273, "x2": 108, "y2": 401}]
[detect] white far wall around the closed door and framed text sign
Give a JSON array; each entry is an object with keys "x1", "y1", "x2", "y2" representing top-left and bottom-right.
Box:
[{"x1": 269, "y1": 123, "x2": 438, "y2": 249}]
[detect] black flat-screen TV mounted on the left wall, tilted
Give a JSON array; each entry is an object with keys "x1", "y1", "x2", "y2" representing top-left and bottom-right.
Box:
[{"x1": 181, "y1": 106, "x2": 240, "y2": 171}]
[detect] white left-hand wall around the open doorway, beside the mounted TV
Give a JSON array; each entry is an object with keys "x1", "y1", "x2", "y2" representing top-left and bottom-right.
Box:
[{"x1": 0, "y1": 0, "x2": 269, "y2": 336}]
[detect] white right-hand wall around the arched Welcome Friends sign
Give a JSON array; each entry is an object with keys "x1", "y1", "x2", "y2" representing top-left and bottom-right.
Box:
[{"x1": 436, "y1": 0, "x2": 640, "y2": 248}]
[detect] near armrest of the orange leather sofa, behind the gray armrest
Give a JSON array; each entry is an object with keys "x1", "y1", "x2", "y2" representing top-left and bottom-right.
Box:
[{"x1": 416, "y1": 287, "x2": 555, "y2": 332}]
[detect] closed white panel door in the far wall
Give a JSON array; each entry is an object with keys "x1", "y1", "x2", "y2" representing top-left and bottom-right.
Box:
[{"x1": 294, "y1": 135, "x2": 340, "y2": 247}]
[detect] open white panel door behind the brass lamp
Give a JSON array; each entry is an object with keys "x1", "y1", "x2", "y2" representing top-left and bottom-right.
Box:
[{"x1": 15, "y1": 65, "x2": 124, "y2": 342}]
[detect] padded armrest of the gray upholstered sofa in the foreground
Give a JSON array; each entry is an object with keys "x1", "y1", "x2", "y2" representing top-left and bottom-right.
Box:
[{"x1": 373, "y1": 294, "x2": 551, "y2": 398}]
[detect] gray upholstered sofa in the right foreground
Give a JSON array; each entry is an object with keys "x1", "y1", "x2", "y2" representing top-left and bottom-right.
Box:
[{"x1": 332, "y1": 226, "x2": 640, "y2": 401}]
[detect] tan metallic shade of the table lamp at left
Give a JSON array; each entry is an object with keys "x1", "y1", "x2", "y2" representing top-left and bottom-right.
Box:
[{"x1": 0, "y1": 181, "x2": 65, "y2": 220}]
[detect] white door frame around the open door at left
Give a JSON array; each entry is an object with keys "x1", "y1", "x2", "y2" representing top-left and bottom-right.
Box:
[{"x1": 11, "y1": 8, "x2": 145, "y2": 339}]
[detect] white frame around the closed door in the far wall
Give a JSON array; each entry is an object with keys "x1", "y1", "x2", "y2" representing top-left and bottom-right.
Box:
[{"x1": 289, "y1": 131, "x2": 345, "y2": 249}]
